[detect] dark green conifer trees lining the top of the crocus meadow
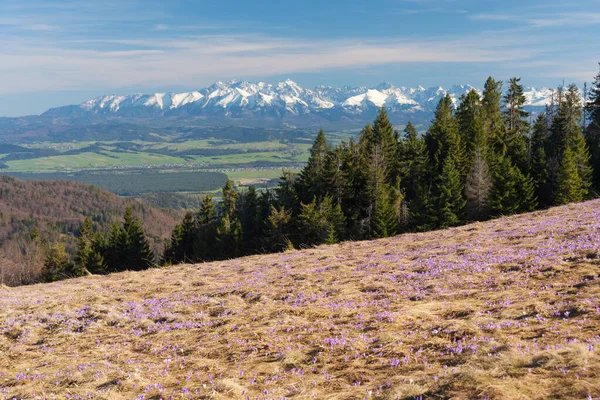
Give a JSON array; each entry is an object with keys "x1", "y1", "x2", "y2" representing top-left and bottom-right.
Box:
[{"x1": 56, "y1": 69, "x2": 600, "y2": 279}]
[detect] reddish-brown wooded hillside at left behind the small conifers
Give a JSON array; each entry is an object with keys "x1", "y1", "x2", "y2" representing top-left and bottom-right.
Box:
[{"x1": 0, "y1": 176, "x2": 180, "y2": 285}]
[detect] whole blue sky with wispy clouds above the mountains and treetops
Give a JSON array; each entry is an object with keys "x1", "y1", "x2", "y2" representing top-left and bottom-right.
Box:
[{"x1": 0, "y1": 0, "x2": 600, "y2": 116}]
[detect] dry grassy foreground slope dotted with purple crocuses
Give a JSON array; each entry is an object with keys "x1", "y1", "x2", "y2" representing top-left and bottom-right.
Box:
[{"x1": 0, "y1": 201, "x2": 600, "y2": 399}]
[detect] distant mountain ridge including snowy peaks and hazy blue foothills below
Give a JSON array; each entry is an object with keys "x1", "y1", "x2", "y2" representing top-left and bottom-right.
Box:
[{"x1": 0, "y1": 79, "x2": 552, "y2": 143}]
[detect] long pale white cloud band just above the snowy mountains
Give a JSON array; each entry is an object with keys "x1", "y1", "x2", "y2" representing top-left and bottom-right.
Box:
[{"x1": 0, "y1": 31, "x2": 531, "y2": 93}]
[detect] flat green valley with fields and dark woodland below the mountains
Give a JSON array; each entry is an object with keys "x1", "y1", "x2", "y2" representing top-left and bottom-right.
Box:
[{"x1": 0, "y1": 133, "x2": 350, "y2": 195}]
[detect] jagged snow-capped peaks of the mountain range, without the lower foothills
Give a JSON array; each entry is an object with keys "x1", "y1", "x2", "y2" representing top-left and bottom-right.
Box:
[{"x1": 44, "y1": 80, "x2": 552, "y2": 120}]
